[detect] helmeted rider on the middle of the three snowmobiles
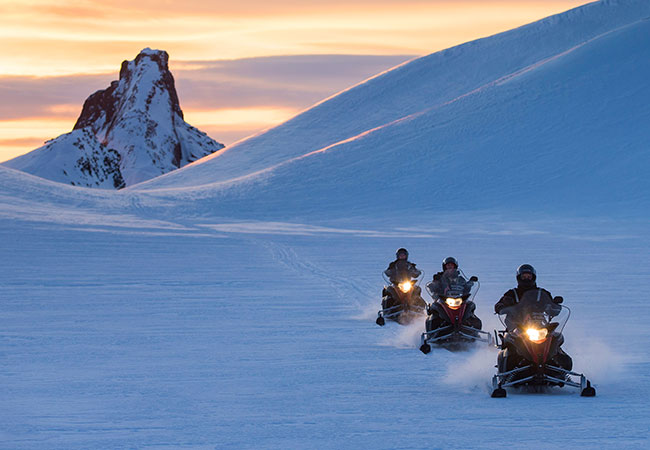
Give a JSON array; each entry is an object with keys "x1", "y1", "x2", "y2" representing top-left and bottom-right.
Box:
[{"x1": 427, "y1": 256, "x2": 483, "y2": 330}]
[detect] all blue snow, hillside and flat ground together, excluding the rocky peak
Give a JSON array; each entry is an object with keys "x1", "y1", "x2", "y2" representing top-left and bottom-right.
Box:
[{"x1": 0, "y1": 1, "x2": 650, "y2": 449}]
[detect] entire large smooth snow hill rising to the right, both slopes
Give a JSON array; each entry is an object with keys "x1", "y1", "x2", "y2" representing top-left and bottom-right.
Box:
[{"x1": 134, "y1": 0, "x2": 650, "y2": 220}]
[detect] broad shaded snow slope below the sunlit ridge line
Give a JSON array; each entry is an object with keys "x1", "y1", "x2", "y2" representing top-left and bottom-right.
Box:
[{"x1": 128, "y1": 5, "x2": 650, "y2": 218}]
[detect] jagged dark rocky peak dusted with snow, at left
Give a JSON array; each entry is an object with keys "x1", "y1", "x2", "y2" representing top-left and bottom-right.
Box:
[{"x1": 4, "y1": 48, "x2": 223, "y2": 189}]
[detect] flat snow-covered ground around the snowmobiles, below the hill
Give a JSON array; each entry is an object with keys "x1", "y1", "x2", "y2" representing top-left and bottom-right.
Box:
[{"x1": 0, "y1": 216, "x2": 650, "y2": 448}]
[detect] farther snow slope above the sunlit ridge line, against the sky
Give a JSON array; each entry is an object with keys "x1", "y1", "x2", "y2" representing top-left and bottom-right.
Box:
[{"x1": 134, "y1": 0, "x2": 650, "y2": 194}]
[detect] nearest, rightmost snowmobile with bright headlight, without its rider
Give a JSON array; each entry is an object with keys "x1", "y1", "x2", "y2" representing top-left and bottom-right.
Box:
[{"x1": 492, "y1": 289, "x2": 596, "y2": 398}]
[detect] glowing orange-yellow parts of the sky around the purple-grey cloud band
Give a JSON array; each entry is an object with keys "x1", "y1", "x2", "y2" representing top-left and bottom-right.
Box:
[{"x1": 0, "y1": 0, "x2": 586, "y2": 161}]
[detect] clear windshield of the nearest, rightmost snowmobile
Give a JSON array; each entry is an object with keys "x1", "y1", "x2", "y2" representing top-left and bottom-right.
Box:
[{"x1": 499, "y1": 289, "x2": 570, "y2": 333}]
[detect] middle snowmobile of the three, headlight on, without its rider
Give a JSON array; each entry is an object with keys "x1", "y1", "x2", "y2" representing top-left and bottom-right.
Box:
[{"x1": 420, "y1": 277, "x2": 493, "y2": 354}]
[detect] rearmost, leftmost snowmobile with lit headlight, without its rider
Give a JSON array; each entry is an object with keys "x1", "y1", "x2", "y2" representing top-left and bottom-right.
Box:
[{"x1": 375, "y1": 271, "x2": 427, "y2": 326}]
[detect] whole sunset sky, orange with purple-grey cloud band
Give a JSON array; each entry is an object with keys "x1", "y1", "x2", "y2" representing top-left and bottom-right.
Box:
[{"x1": 0, "y1": 0, "x2": 587, "y2": 162}]
